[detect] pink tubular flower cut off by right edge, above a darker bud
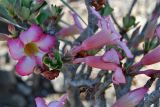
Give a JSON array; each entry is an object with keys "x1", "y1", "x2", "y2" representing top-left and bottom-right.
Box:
[{"x1": 134, "y1": 45, "x2": 160, "y2": 68}]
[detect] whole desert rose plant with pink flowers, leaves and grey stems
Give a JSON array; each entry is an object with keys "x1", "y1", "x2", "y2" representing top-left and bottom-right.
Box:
[{"x1": 0, "y1": 0, "x2": 160, "y2": 107}]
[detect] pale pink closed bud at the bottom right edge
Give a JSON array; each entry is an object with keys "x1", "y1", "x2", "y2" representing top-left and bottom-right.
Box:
[{"x1": 112, "y1": 87, "x2": 148, "y2": 107}]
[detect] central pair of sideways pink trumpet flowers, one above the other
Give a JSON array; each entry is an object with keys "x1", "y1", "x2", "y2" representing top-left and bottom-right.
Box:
[{"x1": 71, "y1": 8, "x2": 133, "y2": 84}]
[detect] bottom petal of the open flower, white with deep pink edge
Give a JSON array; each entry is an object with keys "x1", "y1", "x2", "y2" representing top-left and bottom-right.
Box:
[{"x1": 16, "y1": 56, "x2": 36, "y2": 76}]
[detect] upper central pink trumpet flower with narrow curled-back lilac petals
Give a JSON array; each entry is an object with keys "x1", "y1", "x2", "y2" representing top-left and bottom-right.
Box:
[{"x1": 71, "y1": 8, "x2": 133, "y2": 58}]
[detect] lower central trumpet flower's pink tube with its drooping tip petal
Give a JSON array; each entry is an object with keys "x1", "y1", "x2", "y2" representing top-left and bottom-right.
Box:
[{"x1": 73, "y1": 56, "x2": 126, "y2": 84}]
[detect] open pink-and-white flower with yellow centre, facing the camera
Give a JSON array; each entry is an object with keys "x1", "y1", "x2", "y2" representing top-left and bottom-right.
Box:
[{"x1": 7, "y1": 25, "x2": 56, "y2": 76}]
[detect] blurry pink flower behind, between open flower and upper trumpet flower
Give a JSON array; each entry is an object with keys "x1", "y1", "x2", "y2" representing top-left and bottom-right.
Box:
[{"x1": 56, "y1": 13, "x2": 84, "y2": 37}]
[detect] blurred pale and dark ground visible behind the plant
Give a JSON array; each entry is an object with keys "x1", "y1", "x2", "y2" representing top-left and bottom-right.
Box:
[{"x1": 0, "y1": 0, "x2": 160, "y2": 107}]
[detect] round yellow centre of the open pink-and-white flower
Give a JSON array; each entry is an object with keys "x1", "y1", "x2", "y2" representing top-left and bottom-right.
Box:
[{"x1": 24, "y1": 42, "x2": 38, "y2": 56}]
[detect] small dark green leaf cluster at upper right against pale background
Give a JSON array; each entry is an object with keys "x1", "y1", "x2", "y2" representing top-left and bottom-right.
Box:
[{"x1": 123, "y1": 16, "x2": 136, "y2": 29}]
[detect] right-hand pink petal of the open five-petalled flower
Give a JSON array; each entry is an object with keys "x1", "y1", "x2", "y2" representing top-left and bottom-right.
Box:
[{"x1": 35, "y1": 34, "x2": 56, "y2": 52}]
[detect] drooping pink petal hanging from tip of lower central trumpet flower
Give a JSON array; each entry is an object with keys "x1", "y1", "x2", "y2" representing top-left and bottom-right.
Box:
[{"x1": 112, "y1": 68, "x2": 126, "y2": 85}]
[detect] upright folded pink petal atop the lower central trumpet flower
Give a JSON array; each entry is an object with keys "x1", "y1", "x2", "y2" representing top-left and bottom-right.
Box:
[{"x1": 102, "y1": 48, "x2": 120, "y2": 64}]
